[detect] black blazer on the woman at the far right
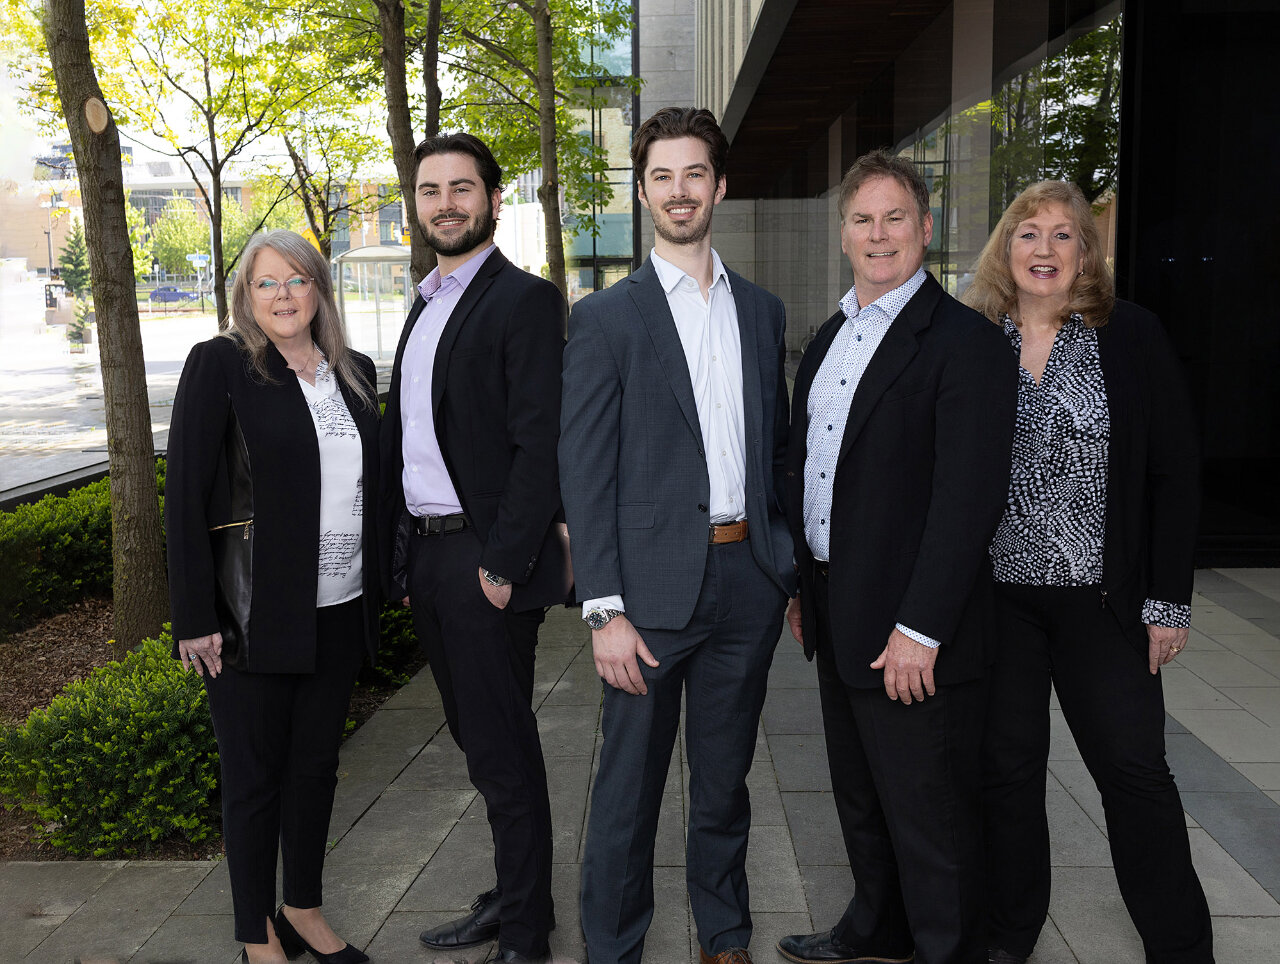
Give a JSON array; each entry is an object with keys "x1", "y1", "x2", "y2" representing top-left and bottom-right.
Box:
[{"x1": 1096, "y1": 301, "x2": 1199, "y2": 653}]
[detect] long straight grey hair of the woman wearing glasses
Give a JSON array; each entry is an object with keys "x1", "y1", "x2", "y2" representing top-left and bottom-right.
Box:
[{"x1": 223, "y1": 230, "x2": 378, "y2": 408}]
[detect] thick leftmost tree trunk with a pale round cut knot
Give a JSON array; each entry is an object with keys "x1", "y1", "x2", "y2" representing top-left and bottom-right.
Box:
[{"x1": 45, "y1": 0, "x2": 169, "y2": 657}]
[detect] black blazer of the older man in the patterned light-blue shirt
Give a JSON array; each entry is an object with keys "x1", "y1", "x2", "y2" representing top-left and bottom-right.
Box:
[{"x1": 787, "y1": 277, "x2": 1018, "y2": 687}]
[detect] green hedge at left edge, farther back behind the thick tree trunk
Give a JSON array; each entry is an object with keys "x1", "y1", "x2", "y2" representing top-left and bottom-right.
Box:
[{"x1": 0, "y1": 461, "x2": 165, "y2": 639}]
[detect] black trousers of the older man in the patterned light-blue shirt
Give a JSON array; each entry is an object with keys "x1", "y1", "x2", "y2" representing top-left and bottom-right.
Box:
[{"x1": 814, "y1": 568, "x2": 987, "y2": 964}]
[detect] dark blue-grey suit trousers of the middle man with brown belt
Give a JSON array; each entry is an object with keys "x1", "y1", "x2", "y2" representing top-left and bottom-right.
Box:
[{"x1": 580, "y1": 542, "x2": 786, "y2": 964}]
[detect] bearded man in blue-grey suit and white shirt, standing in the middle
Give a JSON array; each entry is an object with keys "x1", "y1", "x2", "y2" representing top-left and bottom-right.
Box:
[{"x1": 559, "y1": 108, "x2": 795, "y2": 964}]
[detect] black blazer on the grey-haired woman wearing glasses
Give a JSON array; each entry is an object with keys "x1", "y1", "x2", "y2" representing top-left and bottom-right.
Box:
[{"x1": 165, "y1": 338, "x2": 381, "y2": 673}]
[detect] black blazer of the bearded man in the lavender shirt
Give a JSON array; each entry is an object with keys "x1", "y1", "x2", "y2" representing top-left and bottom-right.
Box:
[{"x1": 379, "y1": 245, "x2": 570, "y2": 612}]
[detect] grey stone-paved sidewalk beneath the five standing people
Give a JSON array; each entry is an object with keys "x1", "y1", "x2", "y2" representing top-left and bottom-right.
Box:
[{"x1": 0, "y1": 570, "x2": 1280, "y2": 964}]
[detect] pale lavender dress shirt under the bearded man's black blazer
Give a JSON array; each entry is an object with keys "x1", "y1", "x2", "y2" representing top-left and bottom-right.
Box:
[{"x1": 401, "y1": 245, "x2": 497, "y2": 516}]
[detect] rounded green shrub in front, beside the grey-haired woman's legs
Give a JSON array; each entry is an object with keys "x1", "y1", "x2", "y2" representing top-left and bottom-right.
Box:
[{"x1": 0, "y1": 627, "x2": 218, "y2": 856}]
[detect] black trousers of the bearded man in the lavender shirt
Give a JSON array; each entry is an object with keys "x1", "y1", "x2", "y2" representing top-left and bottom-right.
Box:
[{"x1": 408, "y1": 529, "x2": 552, "y2": 958}]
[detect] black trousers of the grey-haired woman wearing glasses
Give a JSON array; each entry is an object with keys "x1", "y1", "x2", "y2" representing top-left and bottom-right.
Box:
[{"x1": 205, "y1": 597, "x2": 365, "y2": 944}]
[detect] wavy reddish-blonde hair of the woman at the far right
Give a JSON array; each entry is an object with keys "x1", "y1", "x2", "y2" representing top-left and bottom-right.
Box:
[{"x1": 961, "y1": 181, "x2": 1116, "y2": 328}]
